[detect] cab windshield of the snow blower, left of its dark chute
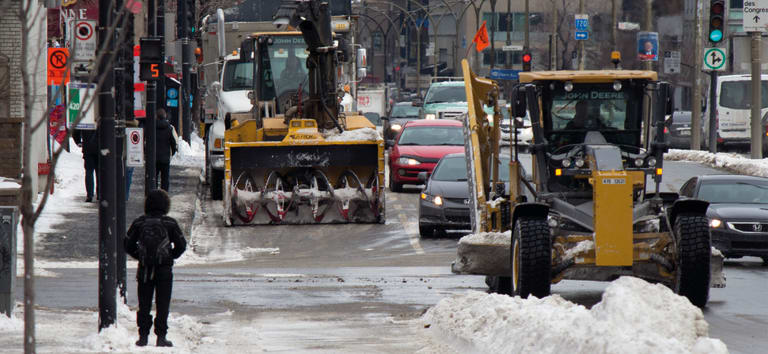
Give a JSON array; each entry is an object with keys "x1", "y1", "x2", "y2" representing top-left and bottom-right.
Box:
[{"x1": 268, "y1": 36, "x2": 309, "y2": 97}]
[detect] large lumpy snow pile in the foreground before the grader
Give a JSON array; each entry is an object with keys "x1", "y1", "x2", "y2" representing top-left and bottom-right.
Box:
[{"x1": 422, "y1": 277, "x2": 728, "y2": 354}]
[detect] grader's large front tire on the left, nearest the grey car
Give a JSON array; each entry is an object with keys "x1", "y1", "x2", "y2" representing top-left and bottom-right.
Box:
[{"x1": 509, "y1": 217, "x2": 552, "y2": 298}]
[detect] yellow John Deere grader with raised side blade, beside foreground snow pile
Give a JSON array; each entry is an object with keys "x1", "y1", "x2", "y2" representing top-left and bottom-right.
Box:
[{"x1": 452, "y1": 60, "x2": 725, "y2": 307}]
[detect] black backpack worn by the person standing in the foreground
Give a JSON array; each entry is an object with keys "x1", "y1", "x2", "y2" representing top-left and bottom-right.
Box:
[{"x1": 137, "y1": 217, "x2": 172, "y2": 266}]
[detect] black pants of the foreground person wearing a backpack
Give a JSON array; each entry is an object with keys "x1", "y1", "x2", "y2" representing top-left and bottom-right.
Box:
[{"x1": 136, "y1": 266, "x2": 173, "y2": 336}]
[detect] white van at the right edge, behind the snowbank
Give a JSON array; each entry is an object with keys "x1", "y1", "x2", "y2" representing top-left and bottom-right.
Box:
[{"x1": 704, "y1": 75, "x2": 768, "y2": 150}]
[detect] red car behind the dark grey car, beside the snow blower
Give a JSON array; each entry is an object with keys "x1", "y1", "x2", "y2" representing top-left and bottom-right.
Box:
[{"x1": 389, "y1": 119, "x2": 464, "y2": 192}]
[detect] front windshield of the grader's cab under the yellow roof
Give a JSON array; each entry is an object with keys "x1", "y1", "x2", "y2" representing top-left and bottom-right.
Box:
[{"x1": 543, "y1": 82, "x2": 643, "y2": 148}]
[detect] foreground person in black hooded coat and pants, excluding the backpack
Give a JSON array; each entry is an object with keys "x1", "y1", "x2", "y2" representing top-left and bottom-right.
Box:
[{"x1": 124, "y1": 189, "x2": 187, "y2": 347}]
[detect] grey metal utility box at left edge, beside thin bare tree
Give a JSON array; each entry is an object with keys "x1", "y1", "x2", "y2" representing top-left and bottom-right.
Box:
[{"x1": 0, "y1": 206, "x2": 17, "y2": 317}]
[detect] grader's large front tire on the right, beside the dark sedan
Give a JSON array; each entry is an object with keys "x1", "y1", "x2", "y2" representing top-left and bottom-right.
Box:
[{"x1": 675, "y1": 214, "x2": 711, "y2": 307}]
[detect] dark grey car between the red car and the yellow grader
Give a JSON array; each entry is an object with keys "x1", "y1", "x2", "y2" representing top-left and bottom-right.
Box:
[{"x1": 419, "y1": 153, "x2": 509, "y2": 238}]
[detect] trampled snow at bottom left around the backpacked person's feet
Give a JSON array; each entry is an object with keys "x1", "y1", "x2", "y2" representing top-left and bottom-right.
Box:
[{"x1": 0, "y1": 302, "x2": 262, "y2": 353}]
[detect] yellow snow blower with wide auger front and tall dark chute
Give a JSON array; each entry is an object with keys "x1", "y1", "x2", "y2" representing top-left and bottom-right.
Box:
[{"x1": 223, "y1": 0, "x2": 384, "y2": 225}]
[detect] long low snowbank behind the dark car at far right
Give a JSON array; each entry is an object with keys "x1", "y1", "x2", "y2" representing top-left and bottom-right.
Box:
[{"x1": 664, "y1": 149, "x2": 768, "y2": 177}]
